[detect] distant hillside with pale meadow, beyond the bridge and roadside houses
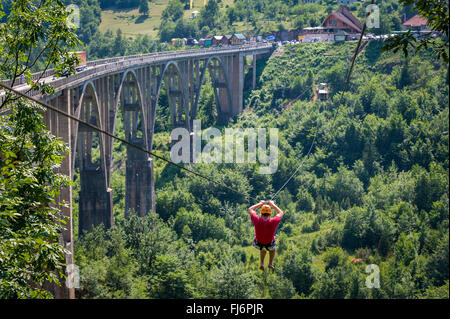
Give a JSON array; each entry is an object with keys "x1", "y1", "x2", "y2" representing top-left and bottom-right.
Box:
[{"x1": 0, "y1": 0, "x2": 414, "y2": 64}]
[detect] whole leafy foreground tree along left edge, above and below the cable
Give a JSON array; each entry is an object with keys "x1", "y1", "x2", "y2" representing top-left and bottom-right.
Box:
[{"x1": 0, "y1": 1, "x2": 79, "y2": 298}]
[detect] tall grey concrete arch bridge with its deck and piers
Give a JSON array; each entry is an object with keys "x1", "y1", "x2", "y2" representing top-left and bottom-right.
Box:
[{"x1": 0, "y1": 43, "x2": 272, "y2": 298}]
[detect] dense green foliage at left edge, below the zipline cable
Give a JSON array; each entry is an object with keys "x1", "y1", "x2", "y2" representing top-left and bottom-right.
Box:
[{"x1": 0, "y1": 100, "x2": 70, "y2": 298}]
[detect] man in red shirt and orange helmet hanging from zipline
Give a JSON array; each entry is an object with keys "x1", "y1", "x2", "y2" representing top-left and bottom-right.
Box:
[{"x1": 248, "y1": 201, "x2": 284, "y2": 271}]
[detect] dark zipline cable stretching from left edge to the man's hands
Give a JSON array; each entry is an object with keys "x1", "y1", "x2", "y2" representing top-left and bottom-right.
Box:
[{"x1": 0, "y1": 83, "x2": 256, "y2": 201}]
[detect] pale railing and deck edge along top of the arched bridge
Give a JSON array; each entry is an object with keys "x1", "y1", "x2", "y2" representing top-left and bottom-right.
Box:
[{"x1": 0, "y1": 43, "x2": 272, "y2": 103}]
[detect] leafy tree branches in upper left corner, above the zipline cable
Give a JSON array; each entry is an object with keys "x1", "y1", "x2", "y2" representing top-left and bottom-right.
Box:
[{"x1": 0, "y1": 1, "x2": 80, "y2": 109}]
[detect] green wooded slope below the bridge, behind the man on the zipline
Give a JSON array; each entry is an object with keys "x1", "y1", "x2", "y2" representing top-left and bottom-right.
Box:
[{"x1": 74, "y1": 41, "x2": 449, "y2": 298}]
